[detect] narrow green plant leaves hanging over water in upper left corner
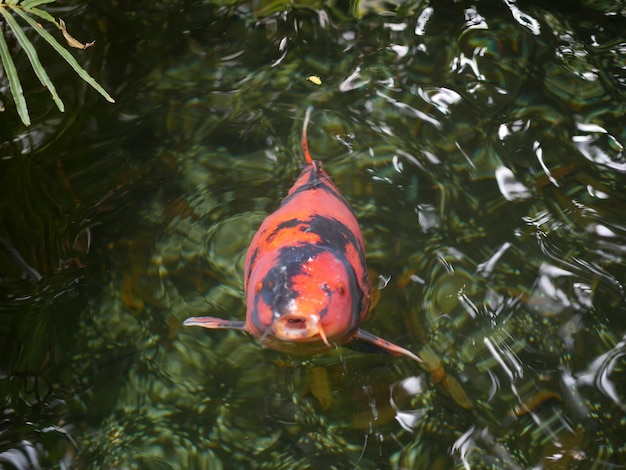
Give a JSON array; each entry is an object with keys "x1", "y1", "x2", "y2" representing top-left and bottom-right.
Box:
[{"x1": 0, "y1": 0, "x2": 115, "y2": 126}]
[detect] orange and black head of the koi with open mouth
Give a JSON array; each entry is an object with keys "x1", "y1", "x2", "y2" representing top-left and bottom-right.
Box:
[{"x1": 246, "y1": 244, "x2": 363, "y2": 354}]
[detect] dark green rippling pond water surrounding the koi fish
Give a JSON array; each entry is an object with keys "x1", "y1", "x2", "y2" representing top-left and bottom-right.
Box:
[{"x1": 0, "y1": 0, "x2": 626, "y2": 469}]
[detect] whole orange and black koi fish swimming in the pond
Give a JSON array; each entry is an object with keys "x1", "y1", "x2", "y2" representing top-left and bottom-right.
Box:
[{"x1": 184, "y1": 108, "x2": 422, "y2": 363}]
